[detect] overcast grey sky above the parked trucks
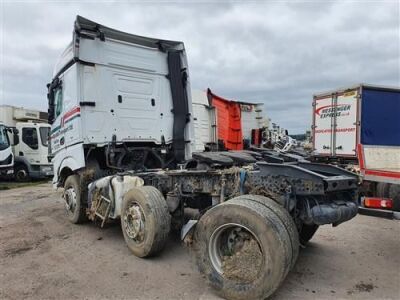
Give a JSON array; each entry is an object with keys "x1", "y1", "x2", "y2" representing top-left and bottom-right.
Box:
[{"x1": 0, "y1": 0, "x2": 400, "y2": 133}]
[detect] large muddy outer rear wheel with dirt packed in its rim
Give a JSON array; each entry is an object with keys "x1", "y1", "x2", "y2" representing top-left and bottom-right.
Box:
[{"x1": 194, "y1": 197, "x2": 292, "y2": 299}]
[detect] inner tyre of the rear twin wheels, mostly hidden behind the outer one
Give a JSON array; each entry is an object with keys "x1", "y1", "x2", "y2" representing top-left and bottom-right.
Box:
[{"x1": 235, "y1": 195, "x2": 300, "y2": 270}]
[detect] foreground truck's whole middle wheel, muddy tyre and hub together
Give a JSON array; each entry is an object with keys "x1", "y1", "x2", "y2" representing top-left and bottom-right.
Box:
[{"x1": 121, "y1": 186, "x2": 171, "y2": 257}]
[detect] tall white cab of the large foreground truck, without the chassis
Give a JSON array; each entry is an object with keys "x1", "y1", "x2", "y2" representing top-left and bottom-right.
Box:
[{"x1": 48, "y1": 16, "x2": 194, "y2": 186}]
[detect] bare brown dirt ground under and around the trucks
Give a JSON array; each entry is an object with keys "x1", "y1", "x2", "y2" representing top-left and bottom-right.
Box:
[{"x1": 0, "y1": 184, "x2": 400, "y2": 299}]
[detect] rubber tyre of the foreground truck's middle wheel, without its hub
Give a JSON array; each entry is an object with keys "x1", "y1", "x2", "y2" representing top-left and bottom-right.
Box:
[{"x1": 121, "y1": 186, "x2": 171, "y2": 257}]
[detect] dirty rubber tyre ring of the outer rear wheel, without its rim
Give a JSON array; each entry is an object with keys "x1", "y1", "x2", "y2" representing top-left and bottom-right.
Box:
[{"x1": 194, "y1": 198, "x2": 292, "y2": 299}]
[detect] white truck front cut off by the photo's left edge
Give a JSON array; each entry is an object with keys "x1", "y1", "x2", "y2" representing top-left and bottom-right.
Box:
[{"x1": 0, "y1": 123, "x2": 14, "y2": 178}]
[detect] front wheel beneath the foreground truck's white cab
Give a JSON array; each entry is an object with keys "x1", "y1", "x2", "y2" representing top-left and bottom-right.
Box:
[{"x1": 63, "y1": 175, "x2": 87, "y2": 224}]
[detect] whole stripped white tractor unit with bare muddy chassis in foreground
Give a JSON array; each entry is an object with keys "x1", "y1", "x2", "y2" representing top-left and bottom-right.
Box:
[{"x1": 48, "y1": 16, "x2": 358, "y2": 299}]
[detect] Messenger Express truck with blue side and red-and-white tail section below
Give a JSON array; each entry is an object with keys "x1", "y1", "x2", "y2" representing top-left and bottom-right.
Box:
[{"x1": 312, "y1": 84, "x2": 400, "y2": 218}]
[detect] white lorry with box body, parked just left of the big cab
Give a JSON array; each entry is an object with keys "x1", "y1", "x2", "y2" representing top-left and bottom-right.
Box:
[{"x1": 0, "y1": 105, "x2": 53, "y2": 181}]
